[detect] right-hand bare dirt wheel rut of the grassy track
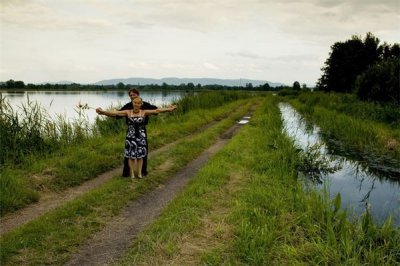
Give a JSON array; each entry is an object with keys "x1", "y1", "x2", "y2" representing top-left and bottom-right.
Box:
[{"x1": 67, "y1": 121, "x2": 245, "y2": 265}]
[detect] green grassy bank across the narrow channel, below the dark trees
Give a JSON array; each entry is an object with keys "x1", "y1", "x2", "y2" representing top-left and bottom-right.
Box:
[{"x1": 289, "y1": 90, "x2": 400, "y2": 181}]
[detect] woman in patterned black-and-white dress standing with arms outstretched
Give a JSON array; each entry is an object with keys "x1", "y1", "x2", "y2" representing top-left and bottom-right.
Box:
[{"x1": 96, "y1": 97, "x2": 176, "y2": 179}]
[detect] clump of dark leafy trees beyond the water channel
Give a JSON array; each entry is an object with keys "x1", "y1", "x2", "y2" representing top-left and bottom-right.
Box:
[{"x1": 316, "y1": 32, "x2": 400, "y2": 105}]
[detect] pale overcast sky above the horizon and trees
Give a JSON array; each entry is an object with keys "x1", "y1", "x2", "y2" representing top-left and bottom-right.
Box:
[{"x1": 0, "y1": 0, "x2": 400, "y2": 86}]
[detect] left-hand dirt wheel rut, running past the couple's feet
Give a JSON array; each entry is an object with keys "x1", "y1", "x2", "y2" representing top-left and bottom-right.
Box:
[{"x1": 0, "y1": 121, "x2": 218, "y2": 236}]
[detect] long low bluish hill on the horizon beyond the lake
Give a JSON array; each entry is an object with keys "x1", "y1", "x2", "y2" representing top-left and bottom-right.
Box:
[{"x1": 94, "y1": 78, "x2": 284, "y2": 87}]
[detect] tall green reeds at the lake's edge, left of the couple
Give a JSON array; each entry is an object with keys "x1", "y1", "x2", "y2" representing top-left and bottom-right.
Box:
[{"x1": 0, "y1": 95, "x2": 97, "y2": 165}]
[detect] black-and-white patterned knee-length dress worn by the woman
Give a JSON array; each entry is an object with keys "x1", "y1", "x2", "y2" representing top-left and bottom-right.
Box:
[{"x1": 125, "y1": 116, "x2": 147, "y2": 159}]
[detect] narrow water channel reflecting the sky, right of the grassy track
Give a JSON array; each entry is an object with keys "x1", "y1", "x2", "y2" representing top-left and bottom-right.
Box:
[{"x1": 279, "y1": 103, "x2": 400, "y2": 225}]
